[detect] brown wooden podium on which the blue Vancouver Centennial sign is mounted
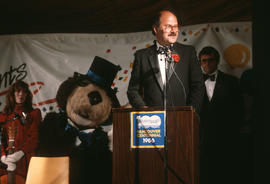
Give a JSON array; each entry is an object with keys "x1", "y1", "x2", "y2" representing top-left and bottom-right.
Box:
[{"x1": 113, "y1": 106, "x2": 200, "y2": 184}]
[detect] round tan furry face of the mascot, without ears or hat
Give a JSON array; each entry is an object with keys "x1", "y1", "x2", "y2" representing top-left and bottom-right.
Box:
[{"x1": 66, "y1": 83, "x2": 112, "y2": 129}]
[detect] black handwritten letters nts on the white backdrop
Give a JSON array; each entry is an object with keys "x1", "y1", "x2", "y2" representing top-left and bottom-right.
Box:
[{"x1": 0, "y1": 63, "x2": 27, "y2": 89}]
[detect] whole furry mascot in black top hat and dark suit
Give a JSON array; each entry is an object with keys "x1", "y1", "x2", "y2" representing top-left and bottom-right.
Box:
[{"x1": 37, "y1": 56, "x2": 121, "y2": 184}]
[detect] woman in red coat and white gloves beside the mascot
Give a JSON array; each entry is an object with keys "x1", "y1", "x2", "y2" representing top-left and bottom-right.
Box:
[{"x1": 0, "y1": 81, "x2": 42, "y2": 182}]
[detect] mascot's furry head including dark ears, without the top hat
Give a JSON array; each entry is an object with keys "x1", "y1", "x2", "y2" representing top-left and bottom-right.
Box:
[{"x1": 56, "y1": 75, "x2": 120, "y2": 129}]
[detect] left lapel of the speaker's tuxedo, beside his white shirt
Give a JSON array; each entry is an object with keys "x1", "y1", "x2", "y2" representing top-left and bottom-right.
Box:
[{"x1": 148, "y1": 46, "x2": 163, "y2": 91}]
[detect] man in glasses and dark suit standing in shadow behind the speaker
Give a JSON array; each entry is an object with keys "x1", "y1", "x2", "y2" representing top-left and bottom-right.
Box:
[{"x1": 199, "y1": 47, "x2": 243, "y2": 184}]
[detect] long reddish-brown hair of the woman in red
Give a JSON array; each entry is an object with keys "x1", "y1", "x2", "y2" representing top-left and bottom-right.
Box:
[{"x1": 3, "y1": 80, "x2": 33, "y2": 114}]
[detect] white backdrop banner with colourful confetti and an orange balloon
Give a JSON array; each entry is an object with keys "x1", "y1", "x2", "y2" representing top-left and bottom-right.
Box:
[{"x1": 0, "y1": 22, "x2": 252, "y2": 115}]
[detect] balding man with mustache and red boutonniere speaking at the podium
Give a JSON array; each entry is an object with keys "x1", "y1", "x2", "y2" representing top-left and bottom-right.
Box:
[{"x1": 127, "y1": 10, "x2": 204, "y2": 112}]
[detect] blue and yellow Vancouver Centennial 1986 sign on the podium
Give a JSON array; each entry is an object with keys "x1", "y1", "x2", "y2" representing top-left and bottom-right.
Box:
[{"x1": 130, "y1": 111, "x2": 165, "y2": 148}]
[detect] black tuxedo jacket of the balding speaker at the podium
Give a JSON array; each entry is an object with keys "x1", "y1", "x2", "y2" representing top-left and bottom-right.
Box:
[{"x1": 127, "y1": 43, "x2": 204, "y2": 112}]
